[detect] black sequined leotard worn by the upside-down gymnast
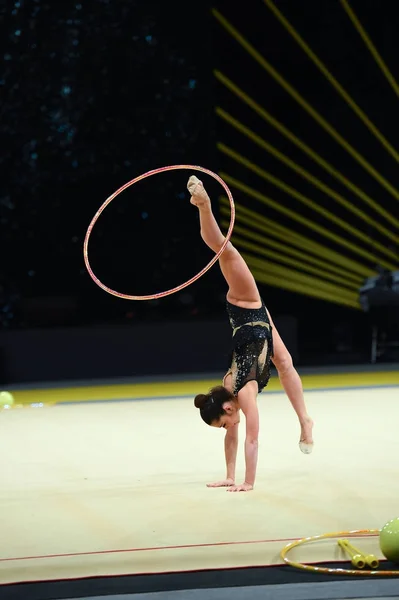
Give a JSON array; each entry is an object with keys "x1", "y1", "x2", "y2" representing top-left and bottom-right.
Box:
[{"x1": 227, "y1": 300, "x2": 273, "y2": 396}]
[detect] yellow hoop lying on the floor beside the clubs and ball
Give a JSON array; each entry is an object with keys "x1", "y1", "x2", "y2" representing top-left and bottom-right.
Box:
[{"x1": 280, "y1": 529, "x2": 399, "y2": 577}]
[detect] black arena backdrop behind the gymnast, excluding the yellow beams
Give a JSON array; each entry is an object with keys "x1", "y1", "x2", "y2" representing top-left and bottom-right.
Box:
[{"x1": 0, "y1": 0, "x2": 399, "y2": 381}]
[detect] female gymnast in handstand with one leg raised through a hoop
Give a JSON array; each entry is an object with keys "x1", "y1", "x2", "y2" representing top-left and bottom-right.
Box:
[{"x1": 187, "y1": 176, "x2": 313, "y2": 492}]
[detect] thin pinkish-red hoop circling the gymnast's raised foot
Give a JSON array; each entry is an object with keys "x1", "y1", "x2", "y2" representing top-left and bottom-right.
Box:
[{"x1": 83, "y1": 165, "x2": 235, "y2": 300}]
